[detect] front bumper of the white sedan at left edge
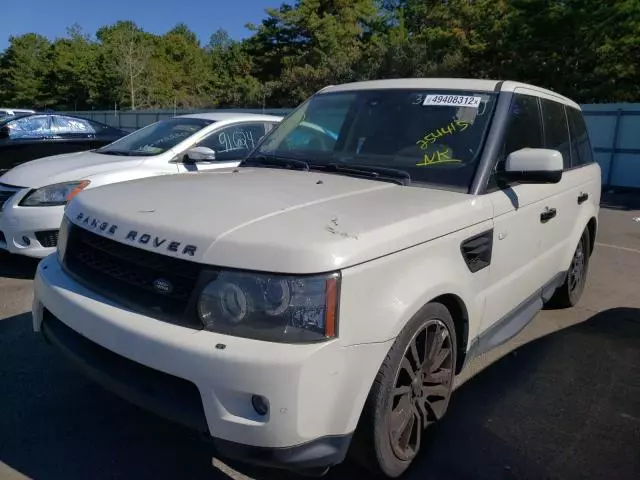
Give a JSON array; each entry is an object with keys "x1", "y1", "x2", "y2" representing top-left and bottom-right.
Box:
[{"x1": 0, "y1": 190, "x2": 64, "y2": 258}]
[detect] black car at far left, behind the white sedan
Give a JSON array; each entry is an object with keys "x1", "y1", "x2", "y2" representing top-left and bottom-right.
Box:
[{"x1": 0, "y1": 113, "x2": 128, "y2": 172}]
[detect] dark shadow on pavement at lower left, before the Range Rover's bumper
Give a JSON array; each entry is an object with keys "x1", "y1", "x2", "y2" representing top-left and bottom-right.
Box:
[{"x1": 0, "y1": 313, "x2": 228, "y2": 480}]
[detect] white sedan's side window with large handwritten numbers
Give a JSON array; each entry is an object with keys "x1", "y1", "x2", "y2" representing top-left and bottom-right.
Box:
[{"x1": 197, "y1": 122, "x2": 265, "y2": 162}]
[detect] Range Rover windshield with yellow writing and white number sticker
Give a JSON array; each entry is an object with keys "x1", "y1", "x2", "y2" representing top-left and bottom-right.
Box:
[{"x1": 249, "y1": 89, "x2": 496, "y2": 190}]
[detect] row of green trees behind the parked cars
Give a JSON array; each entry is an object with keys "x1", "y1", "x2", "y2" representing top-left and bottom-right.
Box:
[{"x1": 0, "y1": 0, "x2": 640, "y2": 109}]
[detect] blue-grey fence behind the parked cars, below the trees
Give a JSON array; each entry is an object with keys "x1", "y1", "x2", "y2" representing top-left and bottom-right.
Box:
[{"x1": 66, "y1": 103, "x2": 640, "y2": 188}]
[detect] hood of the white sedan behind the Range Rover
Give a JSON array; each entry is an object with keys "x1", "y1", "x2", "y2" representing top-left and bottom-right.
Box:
[{"x1": 0, "y1": 151, "x2": 148, "y2": 188}]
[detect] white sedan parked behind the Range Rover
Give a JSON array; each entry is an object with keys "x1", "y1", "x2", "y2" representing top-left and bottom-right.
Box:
[{"x1": 0, "y1": 113, "x2": 281, "y2": 258}]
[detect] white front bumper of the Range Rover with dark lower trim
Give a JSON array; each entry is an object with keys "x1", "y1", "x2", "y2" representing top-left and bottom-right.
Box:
[{"x1": 33, "y1": 255, "x2": 391, "y2": 470}]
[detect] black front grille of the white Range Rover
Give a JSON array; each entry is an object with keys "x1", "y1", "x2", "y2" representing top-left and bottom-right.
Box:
[{"x1": 64, "y1": 224, "x2": 202, "y2": 328}]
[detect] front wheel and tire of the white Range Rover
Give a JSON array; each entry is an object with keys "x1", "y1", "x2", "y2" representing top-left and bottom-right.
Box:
[{"x1": 352, "y1": 303, "x2": 457, "y2": 478}]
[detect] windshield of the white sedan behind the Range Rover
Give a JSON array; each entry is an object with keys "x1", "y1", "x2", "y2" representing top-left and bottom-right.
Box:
[{"x1": 96, "y1": 118, "x2": 214, "y2": 156}]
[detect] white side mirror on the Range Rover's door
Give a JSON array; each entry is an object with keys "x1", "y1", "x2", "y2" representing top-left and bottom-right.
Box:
[{"x1": 500, "y1": 148, "x2": 564, "y2": 183}]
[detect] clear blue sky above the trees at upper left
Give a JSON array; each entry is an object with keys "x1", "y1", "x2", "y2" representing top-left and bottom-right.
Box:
[{"x1": 0, "y1": 0, "x2": 283, "y2": 51}]
